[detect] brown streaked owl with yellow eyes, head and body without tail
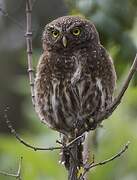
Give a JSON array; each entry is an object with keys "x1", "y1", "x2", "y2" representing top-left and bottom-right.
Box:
[{"x1": 35, "y1": 16, "x2": 116, "y2": 136}]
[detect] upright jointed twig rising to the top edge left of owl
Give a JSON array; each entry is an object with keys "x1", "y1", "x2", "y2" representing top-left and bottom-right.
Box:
[{"x1": 26, "y1": 0, "x2": 35, "y2": 107}]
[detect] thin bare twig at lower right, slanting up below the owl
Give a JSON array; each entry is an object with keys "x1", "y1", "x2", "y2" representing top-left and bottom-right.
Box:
[{"x1": 80, "y1": 141, "x2": 130, "y2": 178}]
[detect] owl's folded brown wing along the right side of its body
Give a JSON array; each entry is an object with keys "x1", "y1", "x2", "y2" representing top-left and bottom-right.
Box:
[{"x1": 89, "y1": 44, "x2": 116, "y2": 111}]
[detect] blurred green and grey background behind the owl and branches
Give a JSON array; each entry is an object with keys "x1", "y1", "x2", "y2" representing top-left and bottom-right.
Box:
[{"x1": 0, "y1": 0, "x2": 137, "y2": 180}]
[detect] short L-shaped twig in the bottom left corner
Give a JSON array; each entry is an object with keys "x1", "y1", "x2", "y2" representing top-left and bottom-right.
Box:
[{"x1": 0, "y1": 157, "x2": 23, "y2": 180}]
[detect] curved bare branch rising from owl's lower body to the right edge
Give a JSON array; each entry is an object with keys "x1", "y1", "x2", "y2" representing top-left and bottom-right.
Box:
[{"x1": 96, "y1": 54, "x2": 137, "y2": 122}]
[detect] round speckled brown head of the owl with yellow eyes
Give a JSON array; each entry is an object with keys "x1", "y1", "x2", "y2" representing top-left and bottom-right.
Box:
[{"x1": 42, "y1": 16, "x2": 99, "y2": 52}]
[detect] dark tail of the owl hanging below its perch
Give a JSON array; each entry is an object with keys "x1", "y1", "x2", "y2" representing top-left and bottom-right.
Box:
[{"x1": 61, "y1": 136, "x2": 83, "y2": 170}]
